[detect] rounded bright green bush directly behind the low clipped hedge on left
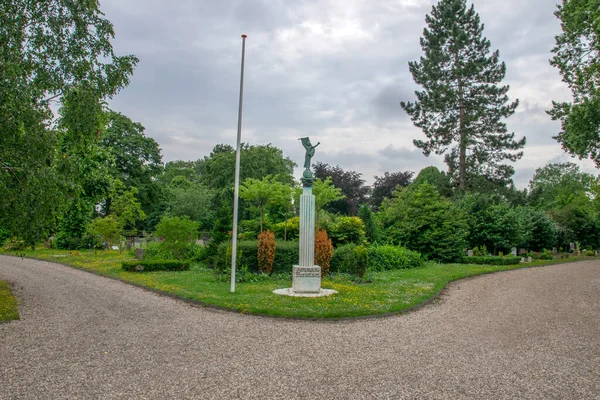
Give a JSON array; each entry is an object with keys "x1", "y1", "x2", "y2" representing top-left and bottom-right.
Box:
[{"x1": 155, "y1": 216, "x2": 198, "y2": 260}]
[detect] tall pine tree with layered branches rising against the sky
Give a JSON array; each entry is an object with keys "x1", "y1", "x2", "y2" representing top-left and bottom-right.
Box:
[{"x1": 400, "y1": 0, "x2": 525, "y2": 191}]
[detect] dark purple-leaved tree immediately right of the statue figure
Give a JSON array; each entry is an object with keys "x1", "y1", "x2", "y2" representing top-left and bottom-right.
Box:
[{"x1": 314, "y1": 162, "x2": 369, "y2": 215}]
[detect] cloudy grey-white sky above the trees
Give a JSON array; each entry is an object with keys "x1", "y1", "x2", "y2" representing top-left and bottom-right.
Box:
[{"x1": 101, "y1": 0, "x2": 597, "y2": 187}]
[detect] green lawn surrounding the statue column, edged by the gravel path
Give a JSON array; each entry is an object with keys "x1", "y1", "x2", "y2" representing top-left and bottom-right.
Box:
[{"x1": 0, "y1": 249, "x2": 590, "y2": 318}]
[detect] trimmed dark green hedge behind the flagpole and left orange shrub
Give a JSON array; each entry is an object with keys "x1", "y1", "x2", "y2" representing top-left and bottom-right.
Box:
[{"x1": 212, "y1": 240, "x2": 300, "y2": 274}]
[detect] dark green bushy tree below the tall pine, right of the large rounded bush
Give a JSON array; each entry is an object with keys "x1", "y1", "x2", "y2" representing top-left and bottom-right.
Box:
[{"x1": 459, "y1": 193, "x2": 523, "y2": 254}]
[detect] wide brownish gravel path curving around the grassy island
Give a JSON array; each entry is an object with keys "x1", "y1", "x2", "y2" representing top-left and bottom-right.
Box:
[{"x1": 0, "y1": 256, "x2": 600, "y2": 399}]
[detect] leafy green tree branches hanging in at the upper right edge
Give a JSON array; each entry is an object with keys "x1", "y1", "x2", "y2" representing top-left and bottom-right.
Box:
[{"x1": 548, "y1": 0, "x2": 600, "y2": 166}]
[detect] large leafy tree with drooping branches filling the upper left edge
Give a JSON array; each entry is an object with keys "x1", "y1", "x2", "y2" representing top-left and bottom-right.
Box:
[{"x1": 0, "y1": 0, "x2": 137, "y2": 245}]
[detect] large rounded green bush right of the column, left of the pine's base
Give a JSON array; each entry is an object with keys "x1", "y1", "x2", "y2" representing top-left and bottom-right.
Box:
[{"x1": 378, "y1": 183, "x2": 468, "y2": 262}]
